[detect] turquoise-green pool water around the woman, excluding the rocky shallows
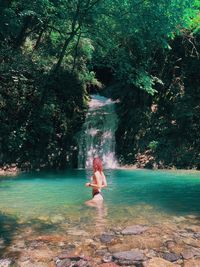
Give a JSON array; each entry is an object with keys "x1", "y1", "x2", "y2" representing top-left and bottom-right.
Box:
[{"x1": 0, "y1": 170, "x2": 200, "y2": 232}]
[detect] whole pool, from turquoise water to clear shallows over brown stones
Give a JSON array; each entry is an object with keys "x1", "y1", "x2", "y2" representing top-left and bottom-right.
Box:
[{"x1": 0, "y1": 169, "x2": 200, "y2": 267}]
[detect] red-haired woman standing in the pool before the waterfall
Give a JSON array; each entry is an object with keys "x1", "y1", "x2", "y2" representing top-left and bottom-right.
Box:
[{"x1": 85, "y1": 157, "x2": 107, "y2": 206}]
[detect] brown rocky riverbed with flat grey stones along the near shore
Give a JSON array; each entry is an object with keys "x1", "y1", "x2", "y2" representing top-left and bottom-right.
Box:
[{"x1": 0, "y1": 216, "x2": 200, "y2": 267}]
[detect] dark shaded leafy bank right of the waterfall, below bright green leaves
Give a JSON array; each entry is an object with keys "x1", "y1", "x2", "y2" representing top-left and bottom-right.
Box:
[{"x1": 115, "y1": 35, "x2": 200, "y2": 169}]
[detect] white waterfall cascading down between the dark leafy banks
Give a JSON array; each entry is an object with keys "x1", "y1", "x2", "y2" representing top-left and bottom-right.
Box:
[{"x1": 78, "y1": 95, "x2": 117, "y2": 169}]
